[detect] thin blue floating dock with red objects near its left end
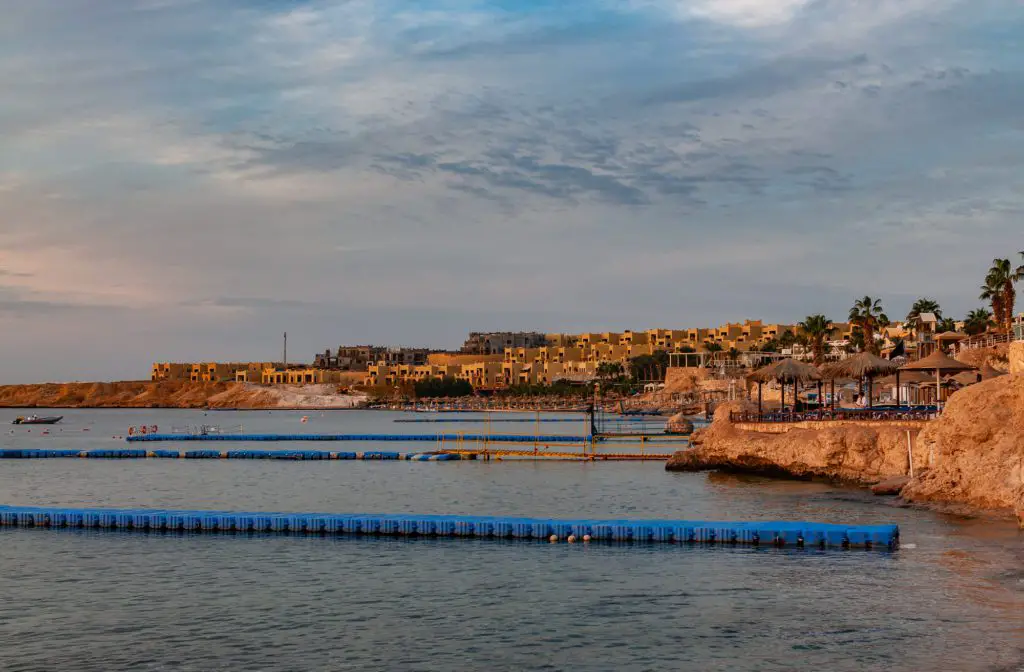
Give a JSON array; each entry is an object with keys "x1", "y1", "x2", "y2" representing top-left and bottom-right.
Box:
[{"x1": 126, "y1": 434, "x2": 592, "y2": 444}]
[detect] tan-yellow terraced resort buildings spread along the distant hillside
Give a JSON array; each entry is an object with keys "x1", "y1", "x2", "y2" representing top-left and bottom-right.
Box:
[{"x1": 151, "y1": 316, "x2": 888, "y2": 389}]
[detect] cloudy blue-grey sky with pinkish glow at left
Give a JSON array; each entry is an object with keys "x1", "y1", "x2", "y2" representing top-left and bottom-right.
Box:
[{"x1": 0, "y1": 0, "x2": 1024, "y2": 383}]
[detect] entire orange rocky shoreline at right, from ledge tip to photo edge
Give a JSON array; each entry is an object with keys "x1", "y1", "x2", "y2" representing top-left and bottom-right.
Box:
[{"x1": 666, "y1": 343, "x2": 1024, "y2": 526}]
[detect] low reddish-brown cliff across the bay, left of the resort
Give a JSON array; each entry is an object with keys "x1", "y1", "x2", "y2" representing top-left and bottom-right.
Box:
[{"x1": 0, "y1": 381, "x2": 362, "y2": 409}]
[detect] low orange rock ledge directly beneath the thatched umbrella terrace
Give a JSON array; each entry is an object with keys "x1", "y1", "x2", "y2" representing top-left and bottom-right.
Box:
[{"x1": 666, "y1": 404, "x2": 927, "y2": 484}]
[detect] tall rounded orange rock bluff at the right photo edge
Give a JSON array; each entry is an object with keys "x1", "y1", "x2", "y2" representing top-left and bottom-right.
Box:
[{"x1": 902, "y1": 372, "x2": 1024, "y2": 515}]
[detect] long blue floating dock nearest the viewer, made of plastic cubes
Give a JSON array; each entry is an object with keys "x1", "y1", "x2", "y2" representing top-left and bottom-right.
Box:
[{"x1": 0, "y1": 506, "x2": 899, "y2": 550}]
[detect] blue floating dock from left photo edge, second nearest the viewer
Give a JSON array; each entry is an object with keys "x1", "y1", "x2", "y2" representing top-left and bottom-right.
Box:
[{"x1": 0, "y1": 448, "x2": 468, "y2": 462}]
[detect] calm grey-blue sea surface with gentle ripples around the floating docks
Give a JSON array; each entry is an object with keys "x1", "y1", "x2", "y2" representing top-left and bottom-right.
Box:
[{"x1": 0, "y1": 411, "x2": 1024, "y2": 671}]
